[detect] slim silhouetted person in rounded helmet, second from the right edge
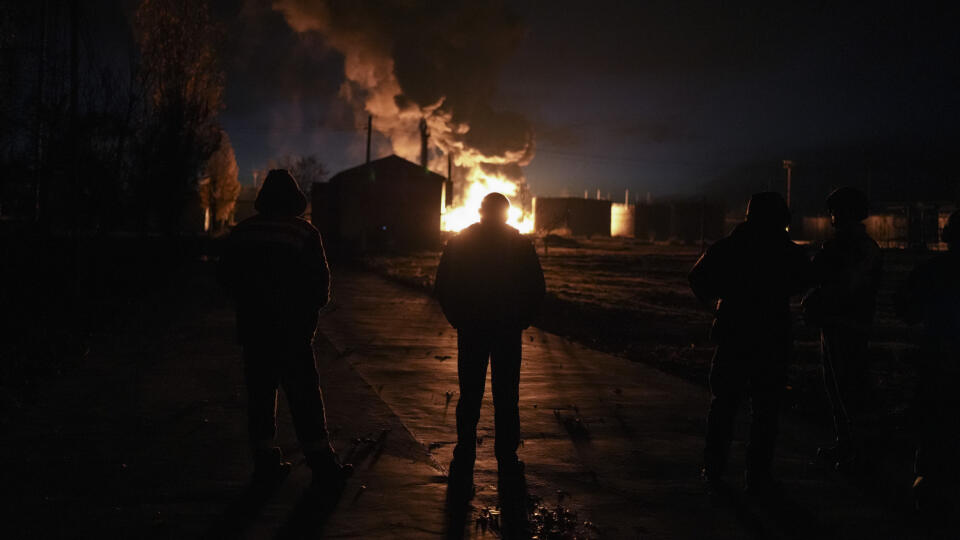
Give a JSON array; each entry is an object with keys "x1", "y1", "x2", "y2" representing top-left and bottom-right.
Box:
[{"x1": 803, "y1": 187, "x2": 883, "y2": 472}]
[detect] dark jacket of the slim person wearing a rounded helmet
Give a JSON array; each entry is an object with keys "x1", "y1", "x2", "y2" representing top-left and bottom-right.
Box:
[{"x1": 804, "y1": 223, "x2": 883, "y2": 332}]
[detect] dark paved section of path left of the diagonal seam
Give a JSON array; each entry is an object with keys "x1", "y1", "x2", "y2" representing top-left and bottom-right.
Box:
[{"x1": 0, "y1": 271, "x2": 445, "y2": 539}]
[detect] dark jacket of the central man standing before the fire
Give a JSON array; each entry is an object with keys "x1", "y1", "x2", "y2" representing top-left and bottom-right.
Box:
[{"x1": 435, "y1": 219, "x2": 546, "y2": 329}]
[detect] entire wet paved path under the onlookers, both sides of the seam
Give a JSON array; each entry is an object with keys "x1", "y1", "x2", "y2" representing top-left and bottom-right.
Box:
[{"x1": 0, "y1": 268, "x2": 928, "y2": 538}]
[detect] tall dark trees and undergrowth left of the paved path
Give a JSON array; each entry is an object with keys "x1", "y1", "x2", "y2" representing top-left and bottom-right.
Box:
[{"x1": 0, "y1": 0, "x2": 240, "y2": 425}]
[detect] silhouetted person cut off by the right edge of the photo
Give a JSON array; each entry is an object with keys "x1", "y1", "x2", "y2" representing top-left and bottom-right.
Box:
[{"x1": 897, "y1": 212, "x2": 960, "y2": 517}]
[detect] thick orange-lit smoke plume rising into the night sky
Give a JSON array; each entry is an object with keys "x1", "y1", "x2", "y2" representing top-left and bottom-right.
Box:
[{"x1": 273, "y1": 0, "x2": 534, "y2": 180}]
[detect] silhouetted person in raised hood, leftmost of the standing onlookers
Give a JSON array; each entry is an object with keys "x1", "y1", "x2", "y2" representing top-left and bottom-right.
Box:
[{"x1": 220, "y1": 169, "x2": 349, "y2": 486}]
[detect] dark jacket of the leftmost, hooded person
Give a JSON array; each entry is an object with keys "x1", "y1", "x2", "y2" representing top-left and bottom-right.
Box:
[{"x1": 219, "y1": 214, "x2": 330, "y2": 344}]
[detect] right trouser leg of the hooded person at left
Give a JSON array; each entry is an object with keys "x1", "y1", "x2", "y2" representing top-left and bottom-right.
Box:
[{"x1": 281, "y1": 341, "x2": 332, "y2": 467}]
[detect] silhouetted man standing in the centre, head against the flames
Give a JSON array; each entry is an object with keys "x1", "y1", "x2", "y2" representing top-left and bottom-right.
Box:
[{"x1": 435, "y1": 193, "x2": 545, "y2": 500}]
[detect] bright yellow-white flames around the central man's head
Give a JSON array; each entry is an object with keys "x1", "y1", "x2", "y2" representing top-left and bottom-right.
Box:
[{"x1": 440, "y1": 168, "x2": 533, "y2": 234}]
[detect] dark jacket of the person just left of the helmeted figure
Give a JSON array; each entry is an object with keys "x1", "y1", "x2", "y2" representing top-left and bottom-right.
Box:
[{"x1": 689, "y1": 221, "x2": 810, "y2": 346}]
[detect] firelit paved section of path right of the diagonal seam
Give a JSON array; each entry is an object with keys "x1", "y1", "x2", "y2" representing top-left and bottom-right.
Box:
[{"x1": 320, "y1": 272, "x2": 924, "y2": 538}]
